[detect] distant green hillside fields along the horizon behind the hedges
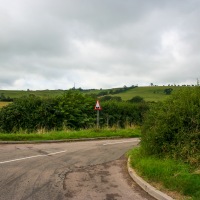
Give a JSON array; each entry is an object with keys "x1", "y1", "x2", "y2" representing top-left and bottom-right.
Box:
[{"x1": 0, "y1": 85, "x2": 192, "y2": 102}]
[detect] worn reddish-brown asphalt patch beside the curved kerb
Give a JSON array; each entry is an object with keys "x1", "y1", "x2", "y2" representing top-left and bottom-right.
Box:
[{"x1": 63, "y1": 156, "x2": 155, "y2": 200}]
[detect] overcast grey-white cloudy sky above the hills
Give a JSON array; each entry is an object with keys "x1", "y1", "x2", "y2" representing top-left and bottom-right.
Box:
[{"x1": 0, "y1": 0, "x2": 200, "y2": 90}]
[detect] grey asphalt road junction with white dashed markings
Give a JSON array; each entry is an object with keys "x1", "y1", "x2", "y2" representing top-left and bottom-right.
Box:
[{"x1": 0, "y1": 139, "x2": 153, "y2": 200}]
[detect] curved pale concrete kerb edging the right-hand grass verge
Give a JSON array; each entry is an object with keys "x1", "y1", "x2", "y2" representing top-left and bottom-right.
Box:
[{"x1": 127, "y1": 156, "x2": 173, "y2": 200}]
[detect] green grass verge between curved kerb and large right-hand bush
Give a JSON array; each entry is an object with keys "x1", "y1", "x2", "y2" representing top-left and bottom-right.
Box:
[{"x1": 128, "y1": 148, "x2": 200, "y2": 200}]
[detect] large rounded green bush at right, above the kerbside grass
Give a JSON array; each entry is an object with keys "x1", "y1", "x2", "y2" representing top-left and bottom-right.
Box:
[{"x1": 141, "y1": 87, "x2": 200, "y2": 165}]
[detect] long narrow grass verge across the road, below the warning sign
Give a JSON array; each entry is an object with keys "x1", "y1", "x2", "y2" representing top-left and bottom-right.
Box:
[{"x1": 0, "y1": 128, "x2": 141, "y2": 141}]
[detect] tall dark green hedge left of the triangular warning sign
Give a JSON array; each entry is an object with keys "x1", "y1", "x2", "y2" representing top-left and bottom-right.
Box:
[{"x1": 0, "y1": 91, "x2": 94, "y2": 132}]
